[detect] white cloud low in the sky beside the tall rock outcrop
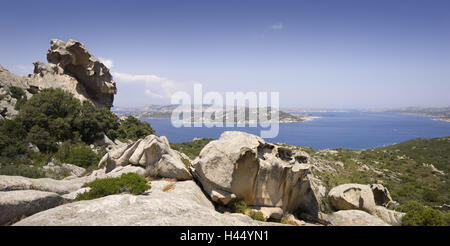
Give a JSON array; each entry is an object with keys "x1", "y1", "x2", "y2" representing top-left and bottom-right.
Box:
[{"x1": 112, "y1": 72, "x2": 192, "y2": 99}]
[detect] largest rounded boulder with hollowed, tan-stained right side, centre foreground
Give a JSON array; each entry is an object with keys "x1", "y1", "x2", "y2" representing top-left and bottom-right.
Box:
[{"x1": 192, "y1": 132, "x2": 320, "y2": 214}]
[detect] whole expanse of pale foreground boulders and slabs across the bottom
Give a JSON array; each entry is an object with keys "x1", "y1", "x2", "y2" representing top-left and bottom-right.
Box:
[{"x1": 0, "y1": 132, "x2": 403, "y2": 226}]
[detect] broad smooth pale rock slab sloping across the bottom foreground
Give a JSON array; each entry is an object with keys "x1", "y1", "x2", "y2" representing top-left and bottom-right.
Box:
[{"x1": 14, "y1": 181, "x2": 275, "y2": 226}]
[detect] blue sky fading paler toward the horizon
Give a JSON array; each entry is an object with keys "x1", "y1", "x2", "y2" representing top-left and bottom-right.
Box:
[{"x1": 0, "y1": 0, "x2": 450, "y2": 108}]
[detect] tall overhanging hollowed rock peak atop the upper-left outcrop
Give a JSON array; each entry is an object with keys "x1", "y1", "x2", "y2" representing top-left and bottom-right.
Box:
[{"x1": 29, "y1": 39, "x2": 117, "y2": 109}]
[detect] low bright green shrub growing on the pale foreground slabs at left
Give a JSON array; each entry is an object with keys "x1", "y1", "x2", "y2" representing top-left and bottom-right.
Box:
[{"x1": 75, "y1": 173, "x2": 151, "y2": 201}]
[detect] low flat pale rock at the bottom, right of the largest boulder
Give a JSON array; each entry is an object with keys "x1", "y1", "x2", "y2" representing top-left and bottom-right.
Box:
[{"x1": 322, "y1": 210, "x2": 389, "y2": 226}]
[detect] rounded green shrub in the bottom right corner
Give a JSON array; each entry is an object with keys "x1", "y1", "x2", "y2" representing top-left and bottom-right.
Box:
[{"x1": 398, "y1": 201, "x2": 448, "y2": 226}]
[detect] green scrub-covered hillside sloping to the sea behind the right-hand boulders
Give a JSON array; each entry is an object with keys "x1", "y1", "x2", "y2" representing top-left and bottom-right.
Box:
[{"x1": 310, "y1": 137, "x2": 450, "y2": 205}]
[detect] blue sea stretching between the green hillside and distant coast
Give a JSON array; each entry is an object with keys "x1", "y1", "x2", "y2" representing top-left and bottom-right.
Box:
[{"x1": 141, "y1": 111, "x2": 450, "y2": 149}]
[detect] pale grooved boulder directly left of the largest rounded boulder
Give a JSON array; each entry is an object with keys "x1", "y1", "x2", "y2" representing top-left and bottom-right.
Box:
[{"x1": 98, "y1": 135, "x2": 192, "y2": 180}]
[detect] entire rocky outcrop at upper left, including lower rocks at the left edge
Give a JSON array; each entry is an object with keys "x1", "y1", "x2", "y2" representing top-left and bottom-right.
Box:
[{"x1": 0, "y1": 39, "x2": 117, "y2": 112}]
